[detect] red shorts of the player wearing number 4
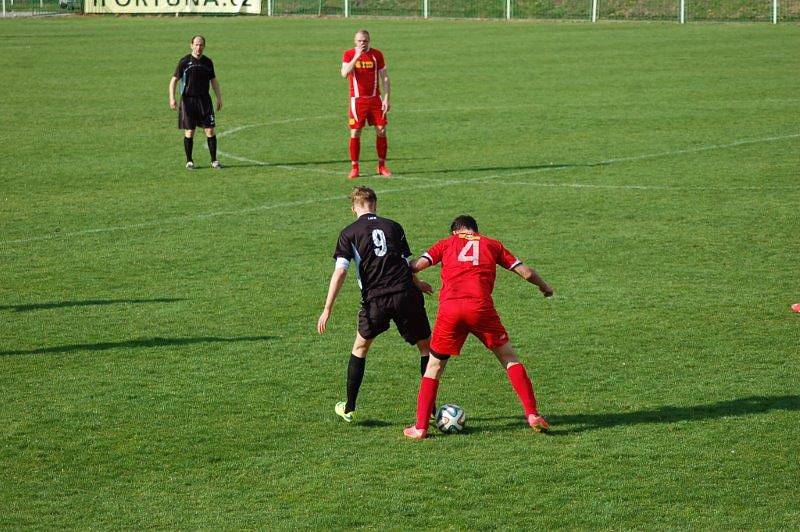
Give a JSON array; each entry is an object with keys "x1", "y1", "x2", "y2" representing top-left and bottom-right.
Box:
[{"x1": 431, "y1": 299, "x2": 508, "y2": 356}]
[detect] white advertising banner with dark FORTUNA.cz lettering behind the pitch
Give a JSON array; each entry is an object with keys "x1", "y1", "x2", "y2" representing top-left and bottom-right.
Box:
[{"x1": 83, "y1": 0, "x2": 261, "y2": 15}]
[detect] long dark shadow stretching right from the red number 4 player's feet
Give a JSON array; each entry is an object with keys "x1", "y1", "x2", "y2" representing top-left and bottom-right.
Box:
[{"x1": 473, "y1": 395, "x2": 800, "y2": 436}]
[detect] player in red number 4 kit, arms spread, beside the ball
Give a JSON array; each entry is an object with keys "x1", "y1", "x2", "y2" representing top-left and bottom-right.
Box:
[{"x1": 403, "y1": 215, "x2": 553, "y2": 440}]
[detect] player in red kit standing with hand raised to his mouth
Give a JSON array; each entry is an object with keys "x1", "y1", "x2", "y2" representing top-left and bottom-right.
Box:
[{"x1": 342, "y1": 30, "x2": 392, "y2": 179}]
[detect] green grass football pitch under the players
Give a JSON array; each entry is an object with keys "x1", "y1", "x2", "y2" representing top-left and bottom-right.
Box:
[{"x1": 0, "y1": 17, "x2": 800, "y2": 529}]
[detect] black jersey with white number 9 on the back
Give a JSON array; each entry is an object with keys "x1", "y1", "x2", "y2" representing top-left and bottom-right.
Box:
[{"x1": 333, "y1": 213, "x2": 414, "y2": 301}]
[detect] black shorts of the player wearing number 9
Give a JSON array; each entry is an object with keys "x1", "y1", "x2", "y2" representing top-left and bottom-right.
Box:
[{"x1": 358, "y1": 287, "x2": 431, "y2": 345}]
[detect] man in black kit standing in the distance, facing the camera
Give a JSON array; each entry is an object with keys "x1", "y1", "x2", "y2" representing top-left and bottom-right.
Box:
[{"x1": 169, "y1": 35, "x2": 222, "y2": 170}]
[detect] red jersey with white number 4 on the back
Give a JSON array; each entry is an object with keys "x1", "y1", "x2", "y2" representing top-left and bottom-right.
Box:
[{"x1": 422, "y1": 233, "x2": 522, "y2": 302}]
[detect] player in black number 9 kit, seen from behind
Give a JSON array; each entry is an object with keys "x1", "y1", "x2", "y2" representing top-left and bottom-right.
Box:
[{"x1": 317, "y1": 186, "x2": 433, "y2": 423}]
